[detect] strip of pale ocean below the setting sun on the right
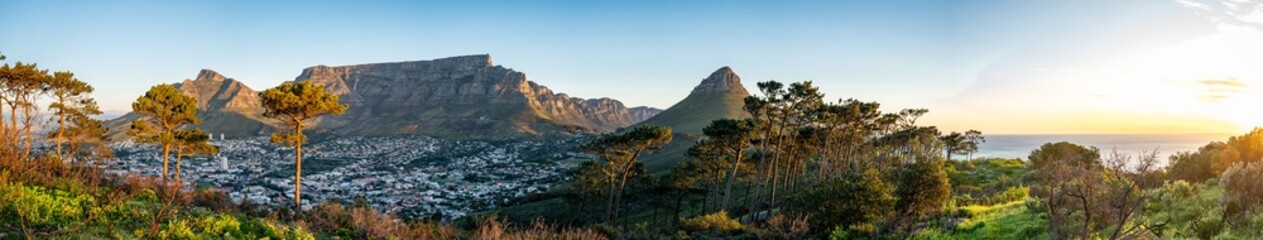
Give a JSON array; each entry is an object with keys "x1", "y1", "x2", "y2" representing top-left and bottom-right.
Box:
[{"x1": 975, "y1": 134, "x2": 1233, "y2": 163}]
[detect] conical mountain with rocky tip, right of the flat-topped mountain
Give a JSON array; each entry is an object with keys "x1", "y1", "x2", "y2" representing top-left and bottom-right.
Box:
[{"x1": 638, "y1": 67, "x2": 750, "y2": 173}]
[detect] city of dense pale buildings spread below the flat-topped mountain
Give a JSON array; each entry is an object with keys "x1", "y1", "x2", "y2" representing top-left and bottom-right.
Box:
[{"x1": 105, "y1": 136, "x2": 584, "y2": 220}]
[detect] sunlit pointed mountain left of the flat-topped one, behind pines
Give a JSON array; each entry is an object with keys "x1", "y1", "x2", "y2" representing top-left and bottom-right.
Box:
[{"x1": 106, "y1": 69, "x2": 274, "y2": 139}]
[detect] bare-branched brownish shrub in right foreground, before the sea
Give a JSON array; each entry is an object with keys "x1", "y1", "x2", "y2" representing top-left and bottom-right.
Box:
[{"x1": 1031, "y1": 144, "x2": 1163, "y2": 239}]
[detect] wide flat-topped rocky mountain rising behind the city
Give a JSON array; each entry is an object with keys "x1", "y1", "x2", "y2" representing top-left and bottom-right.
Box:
[{"x1": 294, "y1": 54, "x2": 652, "y2": 139}]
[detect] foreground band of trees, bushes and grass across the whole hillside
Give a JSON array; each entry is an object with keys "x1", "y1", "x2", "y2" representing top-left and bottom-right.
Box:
[{"x1": 12, "y1": 52, "x2": 1263, "y2": 239}]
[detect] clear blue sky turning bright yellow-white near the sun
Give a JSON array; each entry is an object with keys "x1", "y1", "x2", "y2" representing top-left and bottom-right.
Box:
[{"x1": 0, "y1": 0, "x2": 1263, "y2": 134}]
